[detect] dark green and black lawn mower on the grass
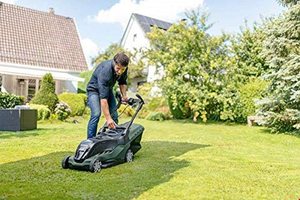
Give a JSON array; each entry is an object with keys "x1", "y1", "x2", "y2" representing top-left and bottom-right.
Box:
[{"x1": 62, "y1": 93, "x2": 144, "y2": 172}]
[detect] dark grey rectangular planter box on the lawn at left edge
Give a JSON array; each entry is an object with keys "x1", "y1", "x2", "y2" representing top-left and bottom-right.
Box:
[{"x1": 0, "y1": 109, "x2": 37, "y2": 131}]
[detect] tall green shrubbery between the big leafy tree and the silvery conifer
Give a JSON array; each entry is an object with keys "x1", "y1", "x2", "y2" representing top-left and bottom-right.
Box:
[{"x1": 230, "y1": 19, "x2": 270, "y2": 122}]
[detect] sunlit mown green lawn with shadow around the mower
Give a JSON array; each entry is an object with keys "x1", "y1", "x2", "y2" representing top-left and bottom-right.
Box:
[{"x1": 0, "y1": 119, "x2": 300, "y2": 200}]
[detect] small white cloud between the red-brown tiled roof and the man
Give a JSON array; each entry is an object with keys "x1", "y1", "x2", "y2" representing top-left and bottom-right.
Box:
[{"x1": 81, "y1": 38, "x2": 100, "y2": 69}]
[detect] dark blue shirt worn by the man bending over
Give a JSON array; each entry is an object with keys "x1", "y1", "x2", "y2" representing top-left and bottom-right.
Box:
[{"x1": 86, "y1": 60, "x2": 128, "y2": 99}]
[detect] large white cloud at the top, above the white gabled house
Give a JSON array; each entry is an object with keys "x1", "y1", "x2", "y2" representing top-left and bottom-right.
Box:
[{"x1": 94, "y1": 0, "x2": 203, "y2": 29}]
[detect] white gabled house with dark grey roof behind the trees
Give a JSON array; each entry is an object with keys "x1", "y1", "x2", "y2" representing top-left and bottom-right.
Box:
[{"x1": 120, "y1": 13, "x2": 172, "y2": 91}]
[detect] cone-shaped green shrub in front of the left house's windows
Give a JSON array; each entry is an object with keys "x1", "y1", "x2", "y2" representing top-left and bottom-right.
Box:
[{"x1": 30, "y1": 73, "x2": 58, "y2": 111}]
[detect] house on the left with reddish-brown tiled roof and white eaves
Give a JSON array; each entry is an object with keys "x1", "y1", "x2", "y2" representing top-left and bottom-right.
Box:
[{"x1": 0, "y1": 1, "x2": 88, "y2": 99}]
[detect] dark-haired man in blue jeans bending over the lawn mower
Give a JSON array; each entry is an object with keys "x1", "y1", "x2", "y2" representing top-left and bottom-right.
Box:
[{"x1": 86, "y1": 52, "x2": 129, "y2": 138}]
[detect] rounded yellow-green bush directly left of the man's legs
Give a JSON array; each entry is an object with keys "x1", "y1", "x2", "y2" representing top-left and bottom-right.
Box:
[{"x1": 58, "y1": 93, "x2": 87, "y2": 116}]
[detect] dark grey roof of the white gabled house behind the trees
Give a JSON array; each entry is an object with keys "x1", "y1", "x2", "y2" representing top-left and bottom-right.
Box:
[{"x1": 132, "y1": 13, "x2": 172, "y2": 33}]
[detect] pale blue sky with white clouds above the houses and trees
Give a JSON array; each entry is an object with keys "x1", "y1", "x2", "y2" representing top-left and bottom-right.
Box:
[{"x1": 1, "y1": 0, "x2": 284, "y2": 68}]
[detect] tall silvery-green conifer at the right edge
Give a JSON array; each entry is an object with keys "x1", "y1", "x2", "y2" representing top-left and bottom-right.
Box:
[{"x1": 258, "y1": 4, "x2": 300, "y2": 132}]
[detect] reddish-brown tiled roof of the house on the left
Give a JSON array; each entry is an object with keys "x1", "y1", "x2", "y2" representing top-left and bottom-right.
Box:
[{"x1": 0, "y1": 1, "x2": 88, "y2": 71}]
